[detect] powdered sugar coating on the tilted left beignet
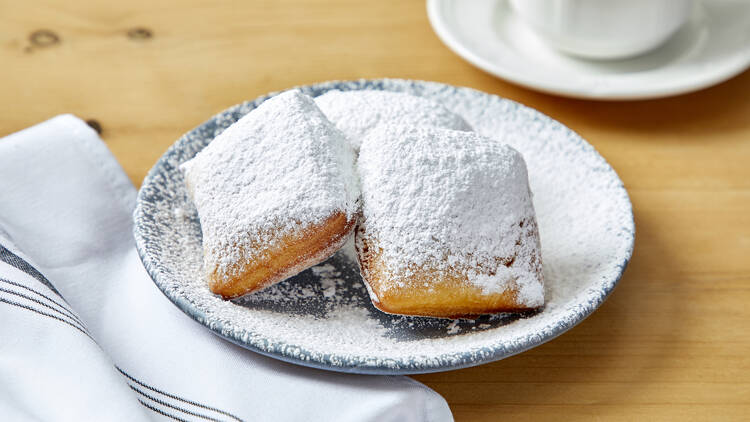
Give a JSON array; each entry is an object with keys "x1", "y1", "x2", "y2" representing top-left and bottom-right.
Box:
[{"x1": 180, "y1": 90, "x2": 359, "y2": 277}]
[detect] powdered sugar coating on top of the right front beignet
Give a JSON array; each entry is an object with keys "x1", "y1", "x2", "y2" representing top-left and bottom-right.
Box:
[{"x1": 358, "y1": 125, "x2": 544, "y2": 307}]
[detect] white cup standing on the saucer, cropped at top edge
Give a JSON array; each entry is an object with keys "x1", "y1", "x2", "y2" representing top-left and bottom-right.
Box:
[{"x1": 510, "y1": 0, "x2": 693, "y2": 59}]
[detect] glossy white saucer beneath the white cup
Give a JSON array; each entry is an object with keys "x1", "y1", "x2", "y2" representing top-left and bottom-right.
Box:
[{"x1": 427, "y1": 0, "x2": 750, "y2": 100}]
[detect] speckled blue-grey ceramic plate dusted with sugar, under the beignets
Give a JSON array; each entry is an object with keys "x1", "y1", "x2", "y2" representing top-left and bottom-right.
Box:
[{"x1": 135, "y1": 79, "x2": 635, "y2": 374}]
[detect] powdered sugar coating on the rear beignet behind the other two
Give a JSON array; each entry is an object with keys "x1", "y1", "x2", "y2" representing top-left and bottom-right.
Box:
[{"x1": 315, "y1": 90, "x2": 471, "y2": 149}]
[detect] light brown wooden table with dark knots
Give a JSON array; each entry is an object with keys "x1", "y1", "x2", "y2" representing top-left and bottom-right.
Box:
[{"x1": 0, "y1": 0, "x2": 750, "y2": 421}]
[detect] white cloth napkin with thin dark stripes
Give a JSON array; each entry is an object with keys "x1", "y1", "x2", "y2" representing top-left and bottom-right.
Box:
[{"x1": 0, "y1": 115, "x2": 452, "y2": 421}]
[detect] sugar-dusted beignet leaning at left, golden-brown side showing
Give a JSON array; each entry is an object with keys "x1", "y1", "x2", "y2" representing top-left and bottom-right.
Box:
[{"x1": 180, "y1": 90, "x2": 359, "y2": 298}]
